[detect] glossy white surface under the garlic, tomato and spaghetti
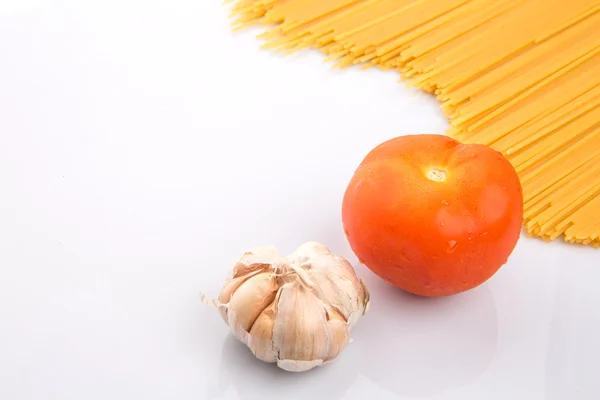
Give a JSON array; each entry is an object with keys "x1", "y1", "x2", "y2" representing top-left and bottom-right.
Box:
[{"x1": 0, "y1": 0, "x2": 600, "y2": 400}]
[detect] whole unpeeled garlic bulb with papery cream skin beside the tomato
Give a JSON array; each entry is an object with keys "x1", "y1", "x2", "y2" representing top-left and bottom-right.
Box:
[{"x1": 211, "y1": 242, "x2": 369, "y2": 371}]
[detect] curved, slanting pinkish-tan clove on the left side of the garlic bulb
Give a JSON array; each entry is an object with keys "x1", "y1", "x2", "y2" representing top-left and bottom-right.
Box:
[{"x1": 227, "y1": 273, "x2": 278, "y2": 344}]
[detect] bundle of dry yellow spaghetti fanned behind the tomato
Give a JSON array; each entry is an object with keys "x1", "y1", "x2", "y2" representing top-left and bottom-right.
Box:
[{"x1": 227, "y1": 0, "x2": 600, "y2": 246}]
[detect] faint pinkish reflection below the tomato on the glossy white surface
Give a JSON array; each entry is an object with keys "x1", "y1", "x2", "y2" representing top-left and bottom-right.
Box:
[{"x1": 354, "y1": 274, "x2": 498, "y2": 398}]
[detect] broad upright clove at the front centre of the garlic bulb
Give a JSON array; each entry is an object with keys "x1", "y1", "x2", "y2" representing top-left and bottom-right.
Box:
[{"x1": 273, "y1": 282, "x2": 331, "y2": 371}]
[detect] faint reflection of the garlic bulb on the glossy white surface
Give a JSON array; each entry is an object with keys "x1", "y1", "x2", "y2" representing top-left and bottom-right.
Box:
[{"x1": 207, "y1": 335, "x2": 360, "y2": 400}]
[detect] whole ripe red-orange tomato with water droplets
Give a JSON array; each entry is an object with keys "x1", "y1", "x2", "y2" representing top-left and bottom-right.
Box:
[{"x1": 342, "y1": 135, "x2": 523, "y2": 296}]
